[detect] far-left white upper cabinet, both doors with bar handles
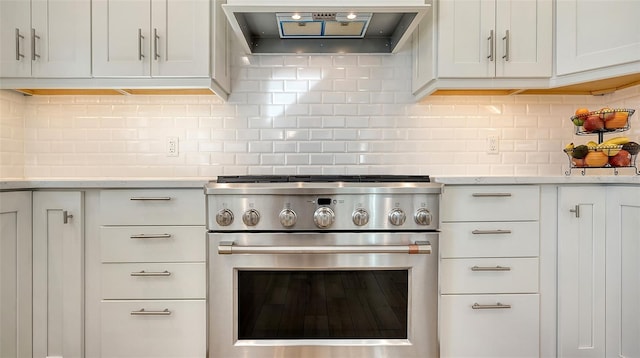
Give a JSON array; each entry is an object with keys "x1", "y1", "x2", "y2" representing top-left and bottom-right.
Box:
[{"x1": 0, "y1": 0, "x2": 91, "y2": 78}]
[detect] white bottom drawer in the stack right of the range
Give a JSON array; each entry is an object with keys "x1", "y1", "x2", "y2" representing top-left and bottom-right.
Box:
[{"x1": 439, "y1": 294, "x2": 540, "y2": 358}]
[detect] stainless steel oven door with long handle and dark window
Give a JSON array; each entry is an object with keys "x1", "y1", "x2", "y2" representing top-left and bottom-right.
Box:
[{"x1": 208, "y1": 232, "x2": 438, "y2": 358}]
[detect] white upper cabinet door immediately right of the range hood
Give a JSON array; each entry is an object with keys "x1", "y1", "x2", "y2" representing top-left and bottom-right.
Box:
[{"x1": 438, "y1": 0, "x2": 497, "y2": 78}]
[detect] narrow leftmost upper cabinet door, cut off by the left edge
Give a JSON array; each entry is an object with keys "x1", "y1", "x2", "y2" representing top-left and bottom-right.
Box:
[{"x1": 0, "y1": 0, "x2": 31, "y2": 77}]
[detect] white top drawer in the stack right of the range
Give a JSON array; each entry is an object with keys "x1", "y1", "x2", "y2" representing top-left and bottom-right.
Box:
[{"x1": 440, "y1": 185, "x2": 540, "y2": 221}]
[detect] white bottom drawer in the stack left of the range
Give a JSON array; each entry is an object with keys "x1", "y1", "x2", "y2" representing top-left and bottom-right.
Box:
[{"x1": 100, "y1": 300, "x2": 207, "y2": 358}]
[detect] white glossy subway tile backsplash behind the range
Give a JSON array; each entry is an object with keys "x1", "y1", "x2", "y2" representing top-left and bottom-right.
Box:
[{"x1": 0, "y1": 43, "x2": 640, "y2": 179}]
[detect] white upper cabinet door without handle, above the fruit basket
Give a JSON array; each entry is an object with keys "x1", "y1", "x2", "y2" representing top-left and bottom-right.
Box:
[{"x1": 555, "y1": 0, "x2": 640, "y2": 75}]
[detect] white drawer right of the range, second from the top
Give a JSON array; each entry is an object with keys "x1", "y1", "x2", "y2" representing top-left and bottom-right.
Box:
[{"x1": 440, "y1": 221, "x2": 540, "y2": 258}]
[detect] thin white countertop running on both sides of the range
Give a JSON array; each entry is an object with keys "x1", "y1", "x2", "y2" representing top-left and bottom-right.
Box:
[{"x1": 0, "y1": 175, "x2": 640, "y2": 190}]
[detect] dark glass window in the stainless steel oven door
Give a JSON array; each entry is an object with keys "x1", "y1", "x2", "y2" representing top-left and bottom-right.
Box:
[{"x1": 238, "y1": 270, "x2": 409, "y2": 340}]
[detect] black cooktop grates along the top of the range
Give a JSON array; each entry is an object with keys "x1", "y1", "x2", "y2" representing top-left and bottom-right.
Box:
[{"x1": 217, "y1": 175, "x2": 431, "y2": 183}]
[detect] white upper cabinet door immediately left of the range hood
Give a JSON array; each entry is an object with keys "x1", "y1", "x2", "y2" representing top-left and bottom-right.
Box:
[{"x1": 151, "y1": 0, "x2": 210, "y2": 77}]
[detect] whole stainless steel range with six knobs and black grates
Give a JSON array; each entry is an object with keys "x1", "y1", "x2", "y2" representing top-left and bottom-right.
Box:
[{"x1": 205, "y1": 176, "x2": 441, "y2": 358}]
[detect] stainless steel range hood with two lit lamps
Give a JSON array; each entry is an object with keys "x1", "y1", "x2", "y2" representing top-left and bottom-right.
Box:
[{"x1": 222, "y1": 0, "x2": 431, "y2": 54}]
